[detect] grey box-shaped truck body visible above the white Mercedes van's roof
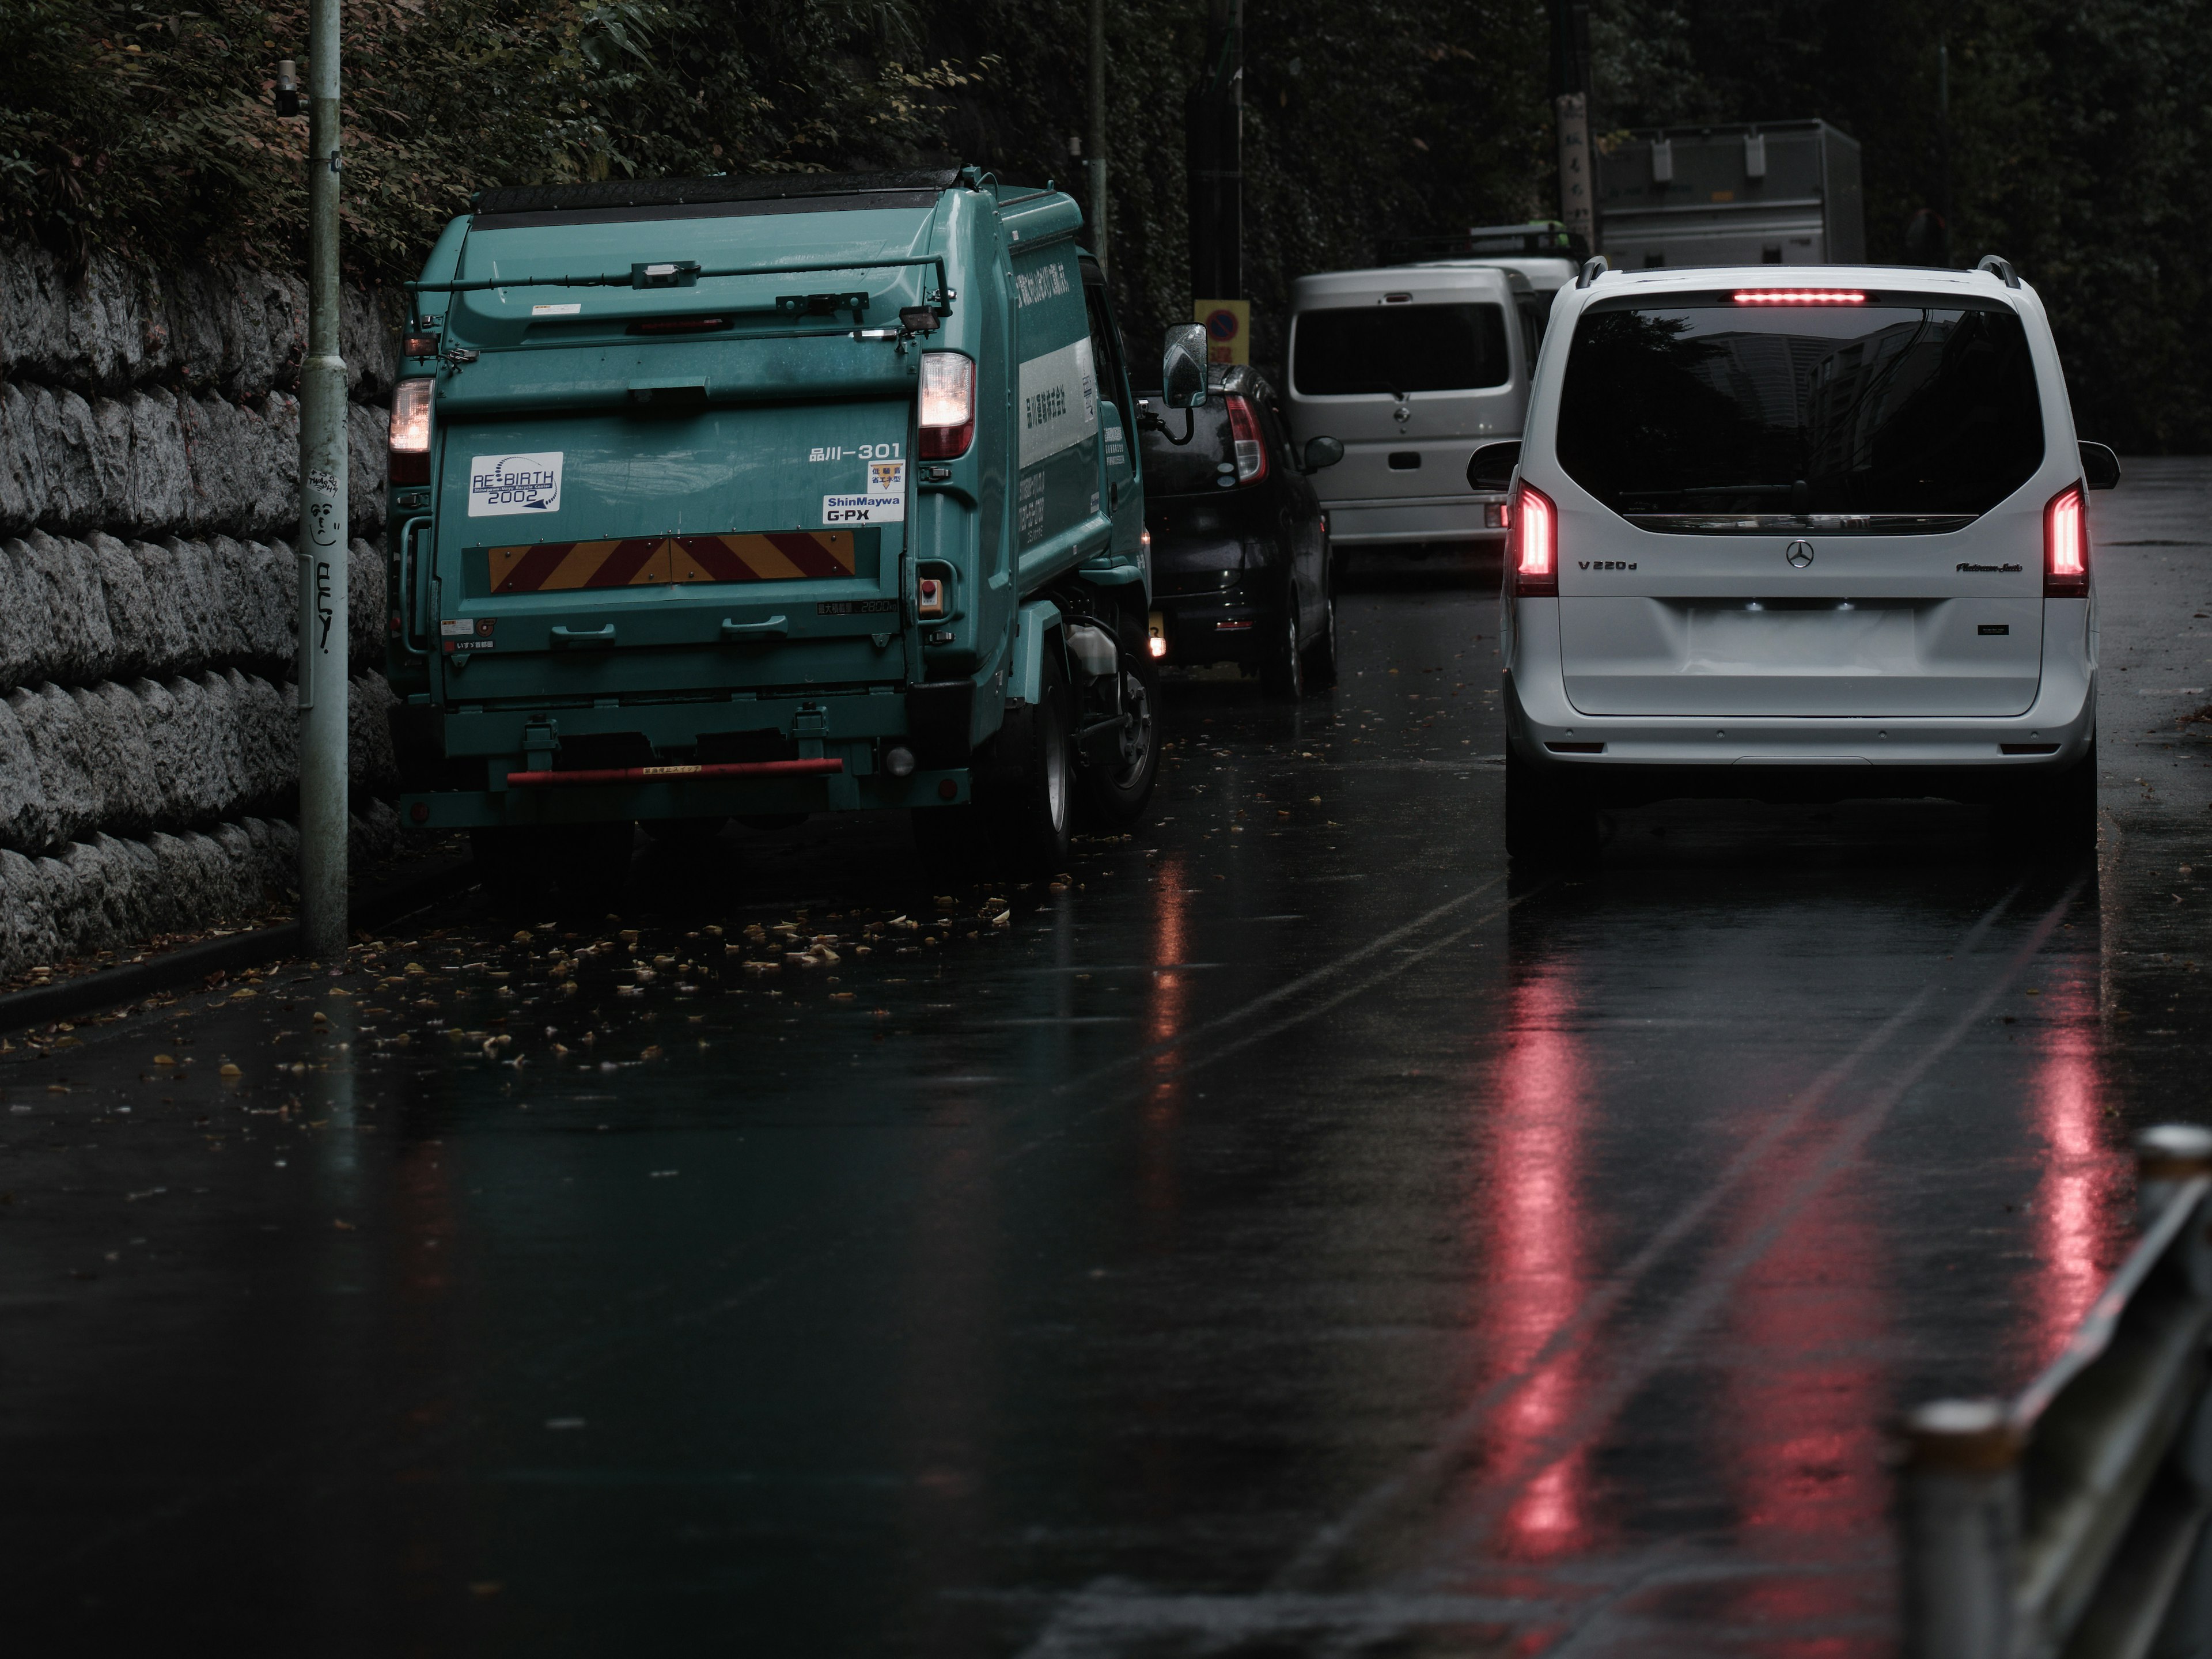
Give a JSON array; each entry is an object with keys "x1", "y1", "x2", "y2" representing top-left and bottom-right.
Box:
[{"x1": 1597, "y1": 122, "x2": 1867, "y2": 270}]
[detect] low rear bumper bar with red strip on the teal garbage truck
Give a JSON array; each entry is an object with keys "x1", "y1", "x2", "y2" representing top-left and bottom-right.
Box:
[{"x1": 400, "y1": 767, "x2": 971, "y2": 830}]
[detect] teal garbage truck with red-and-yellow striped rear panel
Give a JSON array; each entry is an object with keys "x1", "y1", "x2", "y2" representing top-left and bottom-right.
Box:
[{"x1": 389, "y1": 168, "x2": 1206, "y2": 882}]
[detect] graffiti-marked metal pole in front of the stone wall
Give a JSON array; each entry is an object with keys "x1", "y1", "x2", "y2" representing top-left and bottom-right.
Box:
[{"x1": 298, "y1": 0, "x2": 347, "y2": 962}]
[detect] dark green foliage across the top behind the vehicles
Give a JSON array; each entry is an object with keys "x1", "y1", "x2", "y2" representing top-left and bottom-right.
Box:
[{"x1": 0, "y1": 0, "x2": 2212, "y2": 449}]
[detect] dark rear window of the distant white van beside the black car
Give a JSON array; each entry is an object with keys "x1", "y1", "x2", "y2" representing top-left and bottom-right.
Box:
[{"x1": 1290, "y1": 305, "x2": 1513, "y2": 398}]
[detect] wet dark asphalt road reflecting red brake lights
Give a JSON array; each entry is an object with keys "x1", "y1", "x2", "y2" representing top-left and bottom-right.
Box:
[{"x1": 13, "y1": 463, "x2": 2212, "y2": 1659}]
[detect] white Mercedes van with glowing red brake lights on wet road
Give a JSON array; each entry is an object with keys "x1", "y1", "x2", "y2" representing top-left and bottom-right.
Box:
[{"x1": 1502, "y1": 259, "x2": 2119, "y2": 861}]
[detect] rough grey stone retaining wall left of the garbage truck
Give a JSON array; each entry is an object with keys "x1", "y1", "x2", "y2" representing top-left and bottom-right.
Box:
[{"x1": 0, "y1": 245, "x2": 398, "y2": 978}]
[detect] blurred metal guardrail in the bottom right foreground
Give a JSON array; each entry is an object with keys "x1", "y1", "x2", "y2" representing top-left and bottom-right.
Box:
[{"x1": 1898, "y1": 1124, "x2": 2212, "y2": 1659}]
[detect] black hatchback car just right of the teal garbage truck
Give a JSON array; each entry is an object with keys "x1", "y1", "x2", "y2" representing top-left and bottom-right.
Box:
[{"x1": 1137, "y1": 365, "x2": 1345, "y2": 697}]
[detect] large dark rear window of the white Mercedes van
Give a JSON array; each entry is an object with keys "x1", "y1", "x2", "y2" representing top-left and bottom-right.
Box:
[{"x1": 1557, "y1": 301, "x2": 2044, "y2": 535}]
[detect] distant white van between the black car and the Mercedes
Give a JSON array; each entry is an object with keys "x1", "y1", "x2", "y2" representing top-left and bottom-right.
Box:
[{"x1": 1285, "y1": 263, "x2": 1535, "y2": 553}]
